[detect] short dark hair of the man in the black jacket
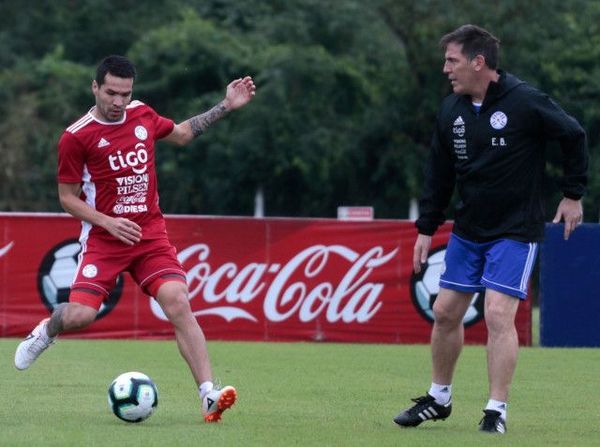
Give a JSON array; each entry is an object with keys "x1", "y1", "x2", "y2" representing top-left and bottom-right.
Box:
[{"x1": 440, "y1": 25, "x2": 500, "y2": 70}]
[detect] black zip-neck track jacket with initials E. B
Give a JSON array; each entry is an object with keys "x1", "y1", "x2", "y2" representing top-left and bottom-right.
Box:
[{"x1": 416, "y1": 70, "x2": 588, "y2": 242}]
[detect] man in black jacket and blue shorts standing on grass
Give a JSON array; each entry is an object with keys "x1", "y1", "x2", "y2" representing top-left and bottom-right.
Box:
[{"x1": 394, "y1": 25, "x2": 588, "y2": 433}]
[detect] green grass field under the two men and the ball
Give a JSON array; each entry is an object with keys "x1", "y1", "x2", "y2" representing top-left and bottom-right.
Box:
[{"x1": 0, "y1": 339, "x2": 600, "y2": 447}]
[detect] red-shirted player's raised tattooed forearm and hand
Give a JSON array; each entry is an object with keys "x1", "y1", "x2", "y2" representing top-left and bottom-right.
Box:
[{"x1": 165, "y1": 76, "x2": 256, "y2": 145}]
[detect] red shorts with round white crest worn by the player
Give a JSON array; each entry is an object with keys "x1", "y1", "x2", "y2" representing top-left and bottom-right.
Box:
[{"x1": 71, "y1": 237, "x2": 185, "y2": 307}]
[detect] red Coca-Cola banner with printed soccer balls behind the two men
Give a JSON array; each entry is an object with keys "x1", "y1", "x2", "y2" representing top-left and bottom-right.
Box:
[{"x1": 0, "y1": 213, "x2": 531, "y2": 345}]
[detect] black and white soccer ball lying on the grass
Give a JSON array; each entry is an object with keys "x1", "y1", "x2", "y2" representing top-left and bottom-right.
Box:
[{"x1": 108, "y1": 371, "x2": 158, "y2": 422}]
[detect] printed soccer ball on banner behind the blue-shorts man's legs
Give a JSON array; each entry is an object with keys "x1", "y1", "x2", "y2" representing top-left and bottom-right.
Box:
[{"x1": 411, "y1": 246, "x2": 484, "y2": 327}]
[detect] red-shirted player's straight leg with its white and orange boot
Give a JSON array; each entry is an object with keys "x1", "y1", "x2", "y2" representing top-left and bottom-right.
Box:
[{"x1": 156, "y1": 281, "x2": 237, "y2": 422}]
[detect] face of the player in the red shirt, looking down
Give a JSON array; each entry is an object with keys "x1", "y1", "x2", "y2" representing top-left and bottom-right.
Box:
[{"x1": 92, "y1": 73, "x2": 133, "y2": 122}]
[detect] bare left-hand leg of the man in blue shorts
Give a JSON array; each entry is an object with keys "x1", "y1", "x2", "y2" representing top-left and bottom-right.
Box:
[{"x1": 431, "y1": 288, "x2": 473, "y2": 385}]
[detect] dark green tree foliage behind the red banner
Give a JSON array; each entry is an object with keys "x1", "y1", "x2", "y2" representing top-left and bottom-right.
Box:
[{"x1": 0, "y1": 0, "x2": 600, "y2": 220}]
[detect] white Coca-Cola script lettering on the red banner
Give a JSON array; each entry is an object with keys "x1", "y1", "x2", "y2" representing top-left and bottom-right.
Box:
[{"x1": 151, "y1": 244, "x2": 399, "y2": 323}]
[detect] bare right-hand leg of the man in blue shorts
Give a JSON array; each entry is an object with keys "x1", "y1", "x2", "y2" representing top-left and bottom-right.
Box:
[{"x1": 485, "y1": 289, "x2": 520, "y2": 402}]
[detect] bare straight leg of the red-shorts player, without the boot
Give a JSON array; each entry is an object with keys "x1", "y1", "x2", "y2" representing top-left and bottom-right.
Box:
[{"x1": 156, "y1": 281, "x2": 212, "y2": 385}]
